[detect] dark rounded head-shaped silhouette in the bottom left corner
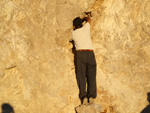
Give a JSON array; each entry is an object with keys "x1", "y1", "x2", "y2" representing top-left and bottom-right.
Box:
[{"x1": 1, "y1": 103, "x2": 15, "y2": 113}]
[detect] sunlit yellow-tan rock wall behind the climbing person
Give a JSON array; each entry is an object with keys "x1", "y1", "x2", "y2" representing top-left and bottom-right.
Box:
[{"x1": 0, "y1": 0, "x2": 150, "y2": 113}]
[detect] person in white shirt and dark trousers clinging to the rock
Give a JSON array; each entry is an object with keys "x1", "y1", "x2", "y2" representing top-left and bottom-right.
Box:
[{"x1": 71, "y1": 17, "x2": 97, "y2": 105}]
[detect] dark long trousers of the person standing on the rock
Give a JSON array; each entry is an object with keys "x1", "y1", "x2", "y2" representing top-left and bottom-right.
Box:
[{"x1": 76, "y1": 51, "x2": 97, "y2": 99}]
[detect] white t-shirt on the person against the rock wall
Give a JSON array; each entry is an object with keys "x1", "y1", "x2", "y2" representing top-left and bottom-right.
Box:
[{"x1": 71, "y1": 22, "x2": 93, "y2": 50}]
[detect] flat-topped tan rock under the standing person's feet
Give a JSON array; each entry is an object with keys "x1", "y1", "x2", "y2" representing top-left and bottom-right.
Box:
[{"x1": 75, "y1": 104, "x2": 102, "y2": 113}]
